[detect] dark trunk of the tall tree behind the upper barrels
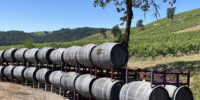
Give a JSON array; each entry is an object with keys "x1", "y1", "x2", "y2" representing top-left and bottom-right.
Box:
[{"x1": 122, "y1": 0, "x2": 133, "y2": 49}]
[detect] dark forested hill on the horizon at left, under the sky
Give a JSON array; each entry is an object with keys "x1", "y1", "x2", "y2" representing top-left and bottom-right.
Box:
[{"x1": 0, "y1": 27, "x2": 108, "y2": 46}]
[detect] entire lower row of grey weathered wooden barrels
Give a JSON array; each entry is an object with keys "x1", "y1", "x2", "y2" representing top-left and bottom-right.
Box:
[{"x1": 0, "y1": 65, "x2": 193, "y2": 100}]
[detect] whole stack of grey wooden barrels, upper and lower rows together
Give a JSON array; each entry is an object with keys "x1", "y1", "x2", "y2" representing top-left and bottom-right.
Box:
[{"x1": 0, "y1": 42, "x2": 193, "y2": 100}]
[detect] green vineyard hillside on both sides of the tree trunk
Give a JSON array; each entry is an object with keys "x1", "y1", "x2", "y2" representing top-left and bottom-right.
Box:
[{"x1": 0, "y1": 9, "x2": 200, "y2": 58}]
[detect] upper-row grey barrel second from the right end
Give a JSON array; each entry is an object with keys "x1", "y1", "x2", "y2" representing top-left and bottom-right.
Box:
[{"x1": 76, "y1": 44, "x2": 96, "y2": 67}]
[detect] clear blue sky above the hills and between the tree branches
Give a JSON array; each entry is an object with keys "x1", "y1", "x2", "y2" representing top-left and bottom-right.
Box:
[{"x1": 0, "y1": 0, "x2": 200, "y2": 32}]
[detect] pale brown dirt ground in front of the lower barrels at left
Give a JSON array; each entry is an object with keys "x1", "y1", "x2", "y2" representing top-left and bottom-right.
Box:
[{"x1": 0, "y1": 82, "x2": 67, "y2": 100}]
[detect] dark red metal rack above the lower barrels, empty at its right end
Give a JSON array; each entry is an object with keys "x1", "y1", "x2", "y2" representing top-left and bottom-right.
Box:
[{"x1": 73, "y1": 65, "x2": 190, "y2": 100}]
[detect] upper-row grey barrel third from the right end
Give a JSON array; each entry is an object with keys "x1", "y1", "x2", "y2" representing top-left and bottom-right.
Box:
[{"x1": 63, "y1": 46, "x2": 81, "y2": 66}]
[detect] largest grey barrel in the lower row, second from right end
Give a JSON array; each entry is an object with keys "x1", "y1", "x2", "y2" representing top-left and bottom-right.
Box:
[{"x1": 119, "y1": 81, "x2": 169, "y2": 100}]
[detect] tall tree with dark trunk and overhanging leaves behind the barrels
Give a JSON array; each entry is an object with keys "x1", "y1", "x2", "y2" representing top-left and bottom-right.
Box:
[{"x1": 94, "y1": 0, "x2": 176, "y2": 48}]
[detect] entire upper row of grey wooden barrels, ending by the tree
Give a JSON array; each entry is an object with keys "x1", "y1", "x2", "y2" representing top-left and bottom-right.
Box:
[{"x1": 0, "y1": 42, "x2": 128, "y2": 69}]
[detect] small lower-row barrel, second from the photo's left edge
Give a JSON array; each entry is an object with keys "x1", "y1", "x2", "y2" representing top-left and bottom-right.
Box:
[{"x1": 4, "y1": 65, "x2": 15, "y2": 79}]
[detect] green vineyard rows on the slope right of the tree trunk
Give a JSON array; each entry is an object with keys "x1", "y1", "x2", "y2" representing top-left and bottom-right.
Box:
[{"x1": 129, "y1": 9, "x2": 200, "y2": 58}]
